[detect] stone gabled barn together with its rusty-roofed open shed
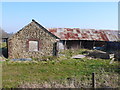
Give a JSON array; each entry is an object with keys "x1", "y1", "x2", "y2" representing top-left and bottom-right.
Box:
[{"x1": 8, "y1": 20, "x2": 118, "y2": 59}]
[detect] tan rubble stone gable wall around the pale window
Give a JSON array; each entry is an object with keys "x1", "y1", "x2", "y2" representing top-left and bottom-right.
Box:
[{"x1": 8, "y1": 21, "x2": 56, "y2": 59}]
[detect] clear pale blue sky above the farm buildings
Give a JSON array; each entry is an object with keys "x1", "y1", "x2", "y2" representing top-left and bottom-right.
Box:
[{"x1": 2, "y1": 2, "x2": 118, "y2": 33}]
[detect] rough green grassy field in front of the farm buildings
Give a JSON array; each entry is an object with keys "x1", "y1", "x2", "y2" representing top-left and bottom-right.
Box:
[{"x1": 2, "y1": 50, "x2": 120, "y2": 88}]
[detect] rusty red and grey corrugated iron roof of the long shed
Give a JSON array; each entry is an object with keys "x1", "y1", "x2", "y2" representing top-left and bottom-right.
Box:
[{"x1": 48, "y1": 28, "x2": 119, "y2": 41}]
